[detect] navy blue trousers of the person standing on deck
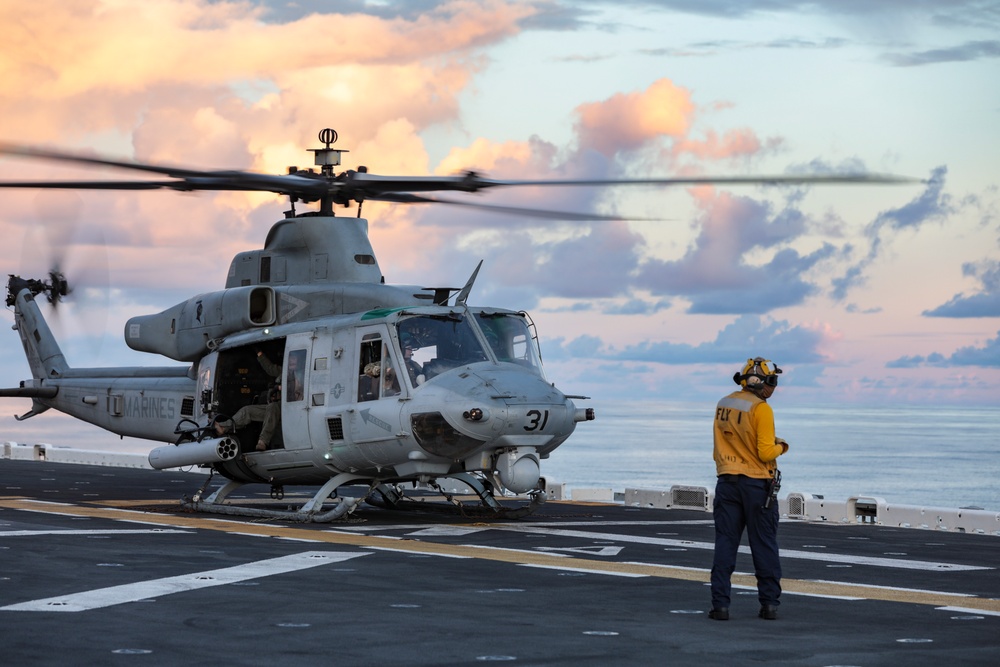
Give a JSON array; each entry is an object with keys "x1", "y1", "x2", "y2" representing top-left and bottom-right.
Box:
[{"x1": 712, "y1": 475, "x2": 781, "y2": 609}]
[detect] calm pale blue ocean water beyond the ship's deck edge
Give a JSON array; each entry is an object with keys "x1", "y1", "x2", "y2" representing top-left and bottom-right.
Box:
[{"x1": 0, "y1": 400, "x2": 1000, "y2": 511}]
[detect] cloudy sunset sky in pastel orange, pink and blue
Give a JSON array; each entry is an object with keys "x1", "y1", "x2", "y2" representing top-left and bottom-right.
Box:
[{"x1": 0, "y1": 0, "x2": 1000, "y2": 454}]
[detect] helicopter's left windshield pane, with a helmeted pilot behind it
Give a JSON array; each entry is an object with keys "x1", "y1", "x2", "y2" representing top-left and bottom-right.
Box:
[{"x1": 397, "y1": 313, "x2": 489, "y2": 387}]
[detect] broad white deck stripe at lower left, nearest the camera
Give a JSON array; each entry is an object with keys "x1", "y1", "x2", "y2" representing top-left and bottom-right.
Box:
[{"x1": 0, "y1": 551, "x2": 367, "y2": 611}]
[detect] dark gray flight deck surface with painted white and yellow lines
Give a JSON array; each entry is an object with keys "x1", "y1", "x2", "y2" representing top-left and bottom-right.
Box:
[{"x1": 0, "y1": 460, "x2": 1000, "y2": 665}]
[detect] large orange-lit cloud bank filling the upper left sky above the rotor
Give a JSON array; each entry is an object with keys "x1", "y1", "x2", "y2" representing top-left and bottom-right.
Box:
[{"x1": 0, "y1": 0, "x2": 534, "y2": 149}]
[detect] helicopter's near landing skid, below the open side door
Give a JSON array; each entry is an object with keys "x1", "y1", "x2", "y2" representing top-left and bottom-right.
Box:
[{"x1": 181, "y1": 473, "x2": 364, "y2": 523}]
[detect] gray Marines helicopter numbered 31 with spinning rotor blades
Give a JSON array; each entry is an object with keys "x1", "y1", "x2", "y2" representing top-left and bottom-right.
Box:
[{"x1": 0, "y1": 129, "x2": 908, "y2": 521}]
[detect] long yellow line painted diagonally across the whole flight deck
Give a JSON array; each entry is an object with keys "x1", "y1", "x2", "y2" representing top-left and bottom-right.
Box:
[{"x1": 0, "y1": 496, "x2": 1000, "y2": 613}]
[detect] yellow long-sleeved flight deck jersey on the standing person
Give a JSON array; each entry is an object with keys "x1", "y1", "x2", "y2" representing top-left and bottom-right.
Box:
[{"x1": 714, "y1": 390, "x2": 788, "y2": 479}]
